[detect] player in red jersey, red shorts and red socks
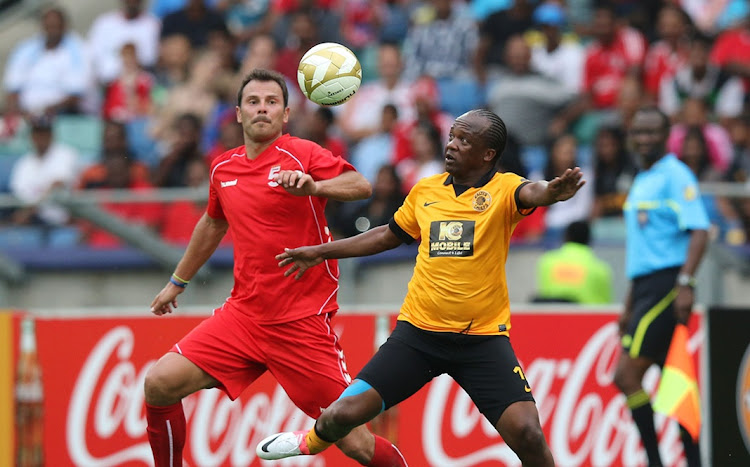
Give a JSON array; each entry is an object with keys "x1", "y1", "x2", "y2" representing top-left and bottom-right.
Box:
[{"x1": 145, "y1": 69, "x2": 406, "y2": 466}]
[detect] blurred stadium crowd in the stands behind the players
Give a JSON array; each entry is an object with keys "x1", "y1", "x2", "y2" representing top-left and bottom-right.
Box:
[{"x1": 0, "y1": 0, "x2": 750, "y2": 248}]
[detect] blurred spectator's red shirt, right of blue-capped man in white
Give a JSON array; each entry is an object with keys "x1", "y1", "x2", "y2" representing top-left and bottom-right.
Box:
[{"x1": 583, "y1": 28, "x2": 646, "y2": 109}]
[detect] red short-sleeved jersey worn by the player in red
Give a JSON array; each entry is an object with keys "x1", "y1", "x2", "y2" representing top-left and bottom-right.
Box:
[{"x1": 206, "y1": 134, "x2": 354, "y2": 324}]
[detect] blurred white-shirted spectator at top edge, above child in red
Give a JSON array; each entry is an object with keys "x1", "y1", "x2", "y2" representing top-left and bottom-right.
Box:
[{"x1": 88, "y1": 0, "x2": 161, "y2": 84}]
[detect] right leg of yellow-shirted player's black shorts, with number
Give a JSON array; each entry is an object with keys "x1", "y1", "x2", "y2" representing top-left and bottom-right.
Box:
[{"x1": 448, "y1": 336, "x2": 534, "y2": 426}]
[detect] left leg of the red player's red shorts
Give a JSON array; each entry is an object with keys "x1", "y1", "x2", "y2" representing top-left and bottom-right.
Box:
[{"x1": 171, "y1": 310, "x2": 266, "y2": 400}]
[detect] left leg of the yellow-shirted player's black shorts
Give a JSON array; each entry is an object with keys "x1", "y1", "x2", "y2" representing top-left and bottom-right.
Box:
[{"x1": 357, "y1": 321, "x2": 444, "y2": 410}]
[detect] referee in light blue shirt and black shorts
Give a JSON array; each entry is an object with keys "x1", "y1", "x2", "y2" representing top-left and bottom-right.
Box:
[{"x1": 615, "y1": 107, "x2": 709, "y2": 467}]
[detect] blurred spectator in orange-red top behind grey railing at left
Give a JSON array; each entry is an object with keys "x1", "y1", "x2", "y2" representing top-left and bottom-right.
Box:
[{"x1": 79, "y1": 151, "x2": 161, "y2": 249}]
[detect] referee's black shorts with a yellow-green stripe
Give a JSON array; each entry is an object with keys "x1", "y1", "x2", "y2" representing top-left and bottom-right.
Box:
[{"x1": 622, "y1": 267, "x2": 680, "y2": 365}]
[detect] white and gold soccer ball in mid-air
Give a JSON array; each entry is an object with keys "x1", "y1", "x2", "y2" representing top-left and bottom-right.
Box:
[{"x1": 297, "y1": 42, "x2": 362, "y2": 106}]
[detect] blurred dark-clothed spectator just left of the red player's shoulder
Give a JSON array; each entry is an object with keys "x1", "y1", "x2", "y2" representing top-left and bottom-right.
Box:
[{"x1": 155, "y1": 114, "x2": 206, "y2": 187}]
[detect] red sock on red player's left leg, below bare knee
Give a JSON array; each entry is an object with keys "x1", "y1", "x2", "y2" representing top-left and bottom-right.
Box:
[{"x1": 146, "y1": 402, "x2": 187, "y2": 467}]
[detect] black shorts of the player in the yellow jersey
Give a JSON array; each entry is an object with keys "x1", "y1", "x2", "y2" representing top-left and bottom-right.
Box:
[{"x1": 357, "y1": 321, "x2": 534, "y2": 426}]
